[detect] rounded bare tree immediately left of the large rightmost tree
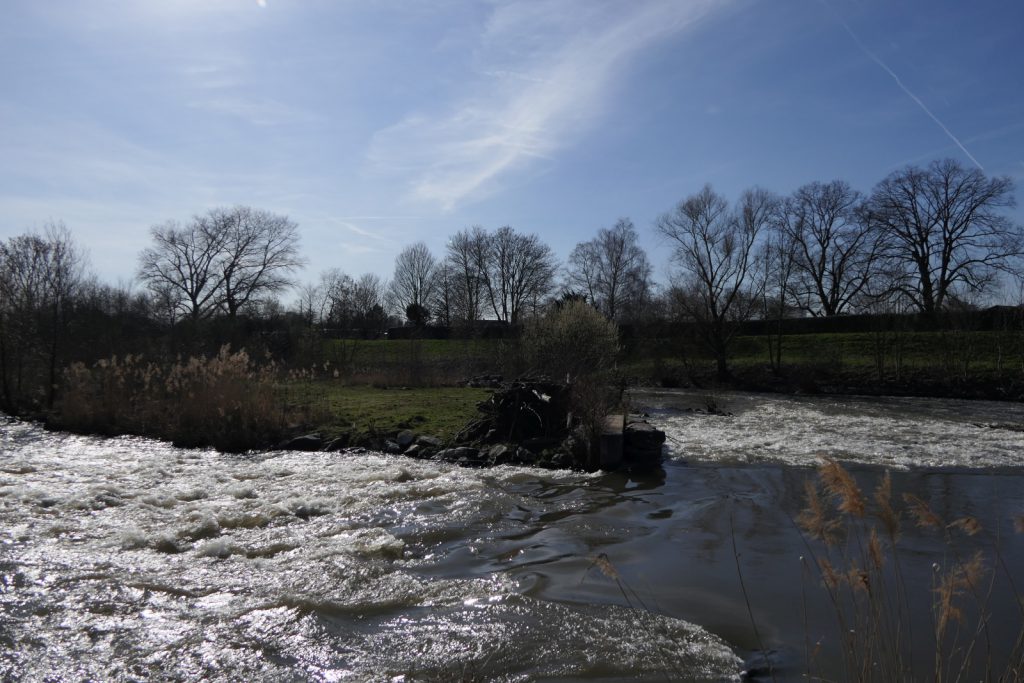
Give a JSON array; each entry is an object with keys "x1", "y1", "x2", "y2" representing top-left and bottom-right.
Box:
[{"x1": 776, "y1": 180, "x2": 879, "y2": 315}]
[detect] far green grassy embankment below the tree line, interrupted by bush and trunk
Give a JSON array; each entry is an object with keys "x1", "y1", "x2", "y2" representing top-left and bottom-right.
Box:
[{"x1": 307, "y1": 330, "x2": 1024, "y2": 397}]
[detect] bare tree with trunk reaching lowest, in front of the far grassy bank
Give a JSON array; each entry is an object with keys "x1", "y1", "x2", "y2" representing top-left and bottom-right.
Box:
[{"x1": 656, "y1": 185, "x2": 775, "y2": 380}]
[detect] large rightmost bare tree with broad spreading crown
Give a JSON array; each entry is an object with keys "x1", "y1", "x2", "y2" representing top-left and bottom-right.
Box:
[{"x1": 868, "y1": 159, "x2": 1022, "y2": 316}]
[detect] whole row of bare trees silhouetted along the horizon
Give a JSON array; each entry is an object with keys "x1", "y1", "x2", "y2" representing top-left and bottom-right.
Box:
[{"x1": 0, "y1": 159, "x2": 1024, "y2": 410}]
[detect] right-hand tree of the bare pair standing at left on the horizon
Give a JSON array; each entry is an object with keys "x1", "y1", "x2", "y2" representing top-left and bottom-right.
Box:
[{"x1": 205, "y1": 206, "x2": 305, "y2": 317}]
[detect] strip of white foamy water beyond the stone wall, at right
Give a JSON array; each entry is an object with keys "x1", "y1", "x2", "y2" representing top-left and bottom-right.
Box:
[{"x1": 632, "y1": 390, "x2": 1024, "y2": 469}]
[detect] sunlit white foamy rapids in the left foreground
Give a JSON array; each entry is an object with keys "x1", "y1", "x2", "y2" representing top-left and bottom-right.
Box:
[{"x1": 0, "y1": 420, "x2": 740, "y2": 681}]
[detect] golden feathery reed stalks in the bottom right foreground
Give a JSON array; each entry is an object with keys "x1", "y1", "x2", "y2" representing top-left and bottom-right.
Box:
[{"x1": 797, "y1": 461, "x2": 1024, "y2": 681}]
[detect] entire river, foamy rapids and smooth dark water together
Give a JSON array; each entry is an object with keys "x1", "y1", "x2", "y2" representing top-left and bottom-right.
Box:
[{"x1": 0, "y1": 392, "x2": 1024, "y2": 681}]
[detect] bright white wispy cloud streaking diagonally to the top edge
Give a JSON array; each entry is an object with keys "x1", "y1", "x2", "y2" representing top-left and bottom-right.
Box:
[{"x1": 370, "y1": 0, "x2": 725, "y2": 210}]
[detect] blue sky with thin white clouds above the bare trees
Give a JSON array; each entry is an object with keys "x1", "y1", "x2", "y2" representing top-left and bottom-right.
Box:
[{"x1": 0, "y1": 0, "x2": 1024, "y2": 290}]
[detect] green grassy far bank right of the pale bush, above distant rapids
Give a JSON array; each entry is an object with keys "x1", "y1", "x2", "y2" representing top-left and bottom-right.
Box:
[{"x1": 620, "y1": 331, "x2": 1024, "y2": 400}]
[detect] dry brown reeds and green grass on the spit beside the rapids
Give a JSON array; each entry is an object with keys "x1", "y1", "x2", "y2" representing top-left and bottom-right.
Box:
[{"x1": 45, "y1": 347, "x2": 487, "y2": 452}]
